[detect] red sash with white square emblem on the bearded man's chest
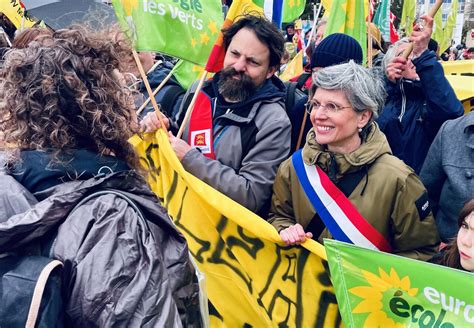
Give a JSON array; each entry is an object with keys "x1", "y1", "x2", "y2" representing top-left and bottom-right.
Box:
[{"x1": 188, "y1": 91, "x2": 216, "y2": 159}]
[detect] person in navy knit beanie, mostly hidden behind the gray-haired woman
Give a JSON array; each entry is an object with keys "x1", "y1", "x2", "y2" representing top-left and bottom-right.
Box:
[{"x1": 286, "y1": 33, "x2": 363, "y2": 152}]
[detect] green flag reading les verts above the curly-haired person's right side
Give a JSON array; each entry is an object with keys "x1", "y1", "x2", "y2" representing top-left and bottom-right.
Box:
[{"x1": 112, "y1": 0, "x2": 223, "y2": 65}]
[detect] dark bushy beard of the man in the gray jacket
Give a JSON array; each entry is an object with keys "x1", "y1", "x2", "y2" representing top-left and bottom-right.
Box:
[{"x1": 217, "y1": 67, "x2": 256, "y2": 103}]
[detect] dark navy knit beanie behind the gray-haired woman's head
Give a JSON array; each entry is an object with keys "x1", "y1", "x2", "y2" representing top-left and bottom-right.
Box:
[{"x1": 311, "y1": 33, "x2": 362, "y2": 68}]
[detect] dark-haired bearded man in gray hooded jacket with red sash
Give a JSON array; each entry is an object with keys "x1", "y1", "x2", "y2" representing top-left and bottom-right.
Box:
[{"x1": 142, "y1": 15, "x2": 291, "y2": 215}]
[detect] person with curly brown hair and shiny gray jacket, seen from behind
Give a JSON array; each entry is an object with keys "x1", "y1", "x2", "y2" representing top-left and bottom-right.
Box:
[{"x1": 0, "y1": 26, "x2": 201, "y2": 327}]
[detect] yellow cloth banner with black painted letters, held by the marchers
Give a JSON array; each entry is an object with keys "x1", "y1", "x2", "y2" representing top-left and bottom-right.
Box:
[{"x1": 130, "y1": 130, "x2": 341, "y2": 327}]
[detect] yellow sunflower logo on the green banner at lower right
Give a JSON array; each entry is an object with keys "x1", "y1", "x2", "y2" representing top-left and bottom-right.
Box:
[{"x1": 349, "y1": 267, "x2": 418, "y2": 328}]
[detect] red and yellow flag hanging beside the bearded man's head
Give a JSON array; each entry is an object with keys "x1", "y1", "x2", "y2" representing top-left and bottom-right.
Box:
[{"x1": 206, "y1": 0, "x2": 263, "y2": 73}]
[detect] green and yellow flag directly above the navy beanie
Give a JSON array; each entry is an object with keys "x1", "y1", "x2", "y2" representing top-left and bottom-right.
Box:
[{"x1": 324, "y1": 0, "x2": 367, "y2": 63}]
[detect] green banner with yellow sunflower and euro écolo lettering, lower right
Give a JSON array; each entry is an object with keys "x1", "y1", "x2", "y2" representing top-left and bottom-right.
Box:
[{"x1": 324, "y1": 240, "x2": 474, "y2": 328}]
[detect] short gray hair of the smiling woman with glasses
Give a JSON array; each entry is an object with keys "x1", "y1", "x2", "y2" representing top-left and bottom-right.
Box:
[{"x1": 313, "y1": 60, "x2": 386, "y2": 120}]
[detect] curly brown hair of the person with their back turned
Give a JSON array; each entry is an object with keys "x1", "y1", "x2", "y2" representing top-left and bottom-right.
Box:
[{"x1": 0, "y1": 26, "x2": 139, "y2": 168}]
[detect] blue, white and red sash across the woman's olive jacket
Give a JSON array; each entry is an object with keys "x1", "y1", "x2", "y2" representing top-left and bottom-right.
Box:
[{"x1": 292, "y1": 150, "x2": 391, "y2": 252}]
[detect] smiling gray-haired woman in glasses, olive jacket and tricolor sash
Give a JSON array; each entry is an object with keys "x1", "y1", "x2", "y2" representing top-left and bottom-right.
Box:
[{"x1": 269, "y1": 61, "x2": 439, "y2": 260}]
